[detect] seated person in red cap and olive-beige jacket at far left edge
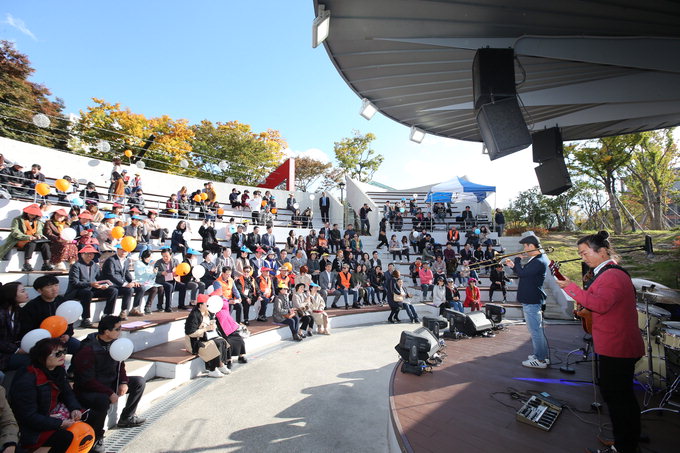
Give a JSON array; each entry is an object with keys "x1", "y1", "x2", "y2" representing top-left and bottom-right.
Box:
[{"x1": 0, "y1": 203, "x2": 54, "y2": 272}]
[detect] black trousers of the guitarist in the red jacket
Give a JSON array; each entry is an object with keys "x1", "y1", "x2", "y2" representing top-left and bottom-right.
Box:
[{"x1": 599, "y1": 355, "x2": 640, "y2": 453}]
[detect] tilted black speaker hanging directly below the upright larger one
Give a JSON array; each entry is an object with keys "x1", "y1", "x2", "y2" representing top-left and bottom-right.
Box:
[{"x1": 477, "y1": 97, "x2": 531, "y2": 160}]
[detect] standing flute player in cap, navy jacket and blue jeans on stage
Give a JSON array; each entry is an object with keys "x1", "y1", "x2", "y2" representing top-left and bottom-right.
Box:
[{"x1": 505, "y1": 235, "x2": 550, "y2": 368}]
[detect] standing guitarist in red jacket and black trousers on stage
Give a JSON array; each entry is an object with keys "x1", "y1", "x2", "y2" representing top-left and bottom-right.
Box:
[{"x1": 557, "y1": 231, "x2": 645, "y2": 453}]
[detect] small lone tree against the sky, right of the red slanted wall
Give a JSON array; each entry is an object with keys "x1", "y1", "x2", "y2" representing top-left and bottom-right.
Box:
[{"x1": 333, "y1": 131, "x2": 384, "y2": 182}]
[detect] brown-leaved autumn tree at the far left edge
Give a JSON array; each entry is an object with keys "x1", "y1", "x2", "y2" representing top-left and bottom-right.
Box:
[{"x1": 0, "y1": 41, "x2": 68, "y2": 149}]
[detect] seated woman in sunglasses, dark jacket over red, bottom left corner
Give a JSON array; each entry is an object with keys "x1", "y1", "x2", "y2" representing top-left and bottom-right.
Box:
[{"x1": 9, "y1": 338, "x2": 84, "y2": 453}]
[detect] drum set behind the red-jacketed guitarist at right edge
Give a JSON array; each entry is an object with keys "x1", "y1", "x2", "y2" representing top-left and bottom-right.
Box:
[{"x1": 635, "y1": 283, "x2": 680, "y2": 413}]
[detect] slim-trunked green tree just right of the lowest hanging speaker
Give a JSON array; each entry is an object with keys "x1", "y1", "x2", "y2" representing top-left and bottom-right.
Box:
[{"x1": 565, "y1": 133, "x2": 642, "y2": 234}]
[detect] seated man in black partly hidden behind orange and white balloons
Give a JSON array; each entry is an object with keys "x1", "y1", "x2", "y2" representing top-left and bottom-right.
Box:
[{"x1": 19, "y1": 275, "x2": 80, "y2": 354}]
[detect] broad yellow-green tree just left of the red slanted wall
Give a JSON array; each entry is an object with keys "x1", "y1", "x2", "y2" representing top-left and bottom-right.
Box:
[{"x1": 191, "y1": 120, "x2": 287, "y2": 185}]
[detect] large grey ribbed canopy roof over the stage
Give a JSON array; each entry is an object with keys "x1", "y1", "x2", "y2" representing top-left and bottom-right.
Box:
[{"x1": 313, "y1": 0, "x2": 680, "y2": 141}]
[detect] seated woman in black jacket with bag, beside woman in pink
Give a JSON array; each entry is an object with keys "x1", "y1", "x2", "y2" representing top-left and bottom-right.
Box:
[{"x1": 184, "y1": 297, "x2": 231, "y2": 378}]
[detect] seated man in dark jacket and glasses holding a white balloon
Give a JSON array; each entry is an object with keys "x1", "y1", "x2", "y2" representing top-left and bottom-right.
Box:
[{"x1": 73, "y1": 315, "x2": 146, "y2": 448}]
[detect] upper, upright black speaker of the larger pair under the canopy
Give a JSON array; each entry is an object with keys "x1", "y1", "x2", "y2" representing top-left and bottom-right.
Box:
[{"x1": 472, "y1": 49, "x2": 517, "y2": 109}]
